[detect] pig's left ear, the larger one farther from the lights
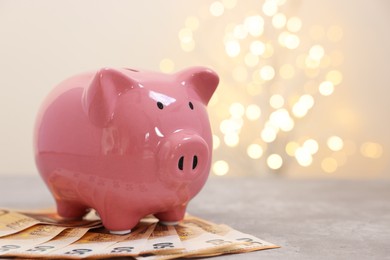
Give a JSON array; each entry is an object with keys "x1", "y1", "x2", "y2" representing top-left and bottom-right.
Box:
[{"x1": 82, "y1": 68, "x2": 138, "y2": 127}]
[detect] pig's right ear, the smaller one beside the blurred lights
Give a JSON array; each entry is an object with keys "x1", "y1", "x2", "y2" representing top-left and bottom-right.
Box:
[{"x1": 178, "y1": 67, "x2": 219, "y2": 105}]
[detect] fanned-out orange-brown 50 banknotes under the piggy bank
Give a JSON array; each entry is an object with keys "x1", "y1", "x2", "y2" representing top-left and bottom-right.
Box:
[{"x1": 0, "y1": 209, "x2": 278, "y2": 260}]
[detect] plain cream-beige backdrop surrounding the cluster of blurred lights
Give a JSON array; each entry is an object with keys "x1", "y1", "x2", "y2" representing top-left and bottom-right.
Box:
[{"x1": 0, "y1": 0, "x2": 390, "y2": 178}]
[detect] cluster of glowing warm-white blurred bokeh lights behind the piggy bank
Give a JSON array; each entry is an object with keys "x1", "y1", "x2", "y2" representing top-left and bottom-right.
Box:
[{"x1": 166, "y1": 0, "x2": 384, "y2": 176}]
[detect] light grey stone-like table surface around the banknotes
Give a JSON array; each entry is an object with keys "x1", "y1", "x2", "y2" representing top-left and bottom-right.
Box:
[{"x1": 0, "y1": 175, "x2": 390, "y2": 259}]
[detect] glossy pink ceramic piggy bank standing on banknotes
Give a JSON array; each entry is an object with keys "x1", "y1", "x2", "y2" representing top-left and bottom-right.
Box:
[{"x1": 34, "y1": 67, "x2": 219, "y2": 234}]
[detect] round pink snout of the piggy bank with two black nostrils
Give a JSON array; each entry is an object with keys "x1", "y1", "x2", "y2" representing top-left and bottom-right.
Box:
[{"x1": 159, "y1": 133, "x2": 210, "y2": 181}]
